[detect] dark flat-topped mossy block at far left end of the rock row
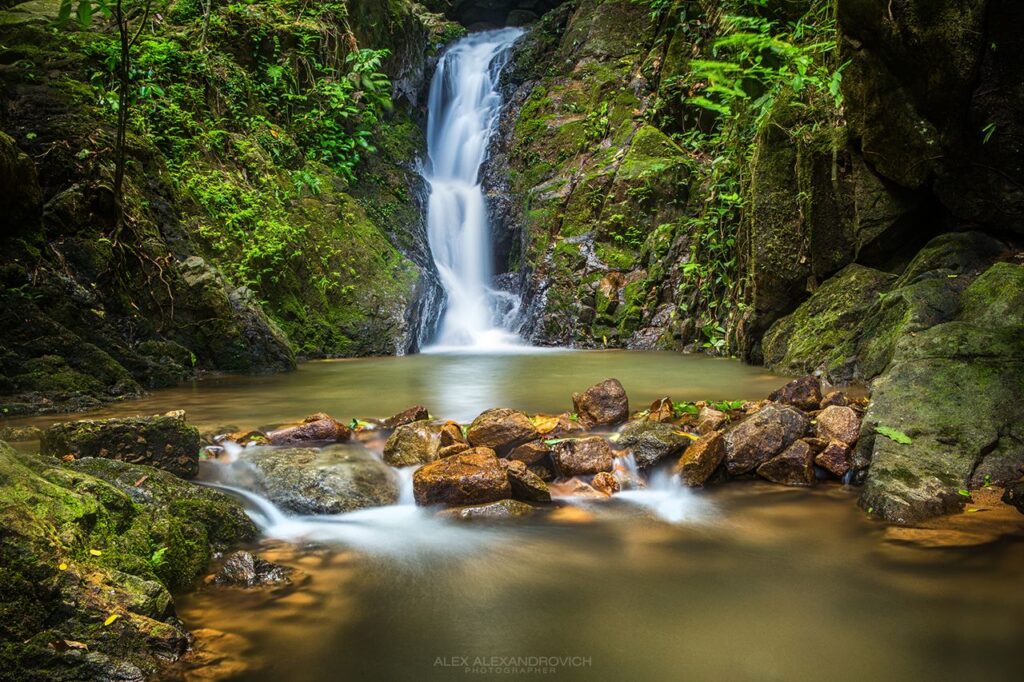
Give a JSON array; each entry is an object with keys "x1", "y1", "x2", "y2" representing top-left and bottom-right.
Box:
[{"x1": 40, "y1": 416, "x2": 200, "y2": 478}]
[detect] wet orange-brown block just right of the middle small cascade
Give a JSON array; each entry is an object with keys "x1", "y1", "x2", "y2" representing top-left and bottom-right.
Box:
[{"x1": 413, "y1": 447, "x2": 512, "y2": 506}]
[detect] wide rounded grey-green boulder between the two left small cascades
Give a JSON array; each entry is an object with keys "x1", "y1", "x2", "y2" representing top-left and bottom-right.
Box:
[{"x1": 241, "y1": 445, "x2": 398, "y2": 514}]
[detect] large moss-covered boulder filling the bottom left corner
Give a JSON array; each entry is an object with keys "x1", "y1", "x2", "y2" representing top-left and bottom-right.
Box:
[{"x1": 0, "y1": 443, "x2": 256, "y2": 680}]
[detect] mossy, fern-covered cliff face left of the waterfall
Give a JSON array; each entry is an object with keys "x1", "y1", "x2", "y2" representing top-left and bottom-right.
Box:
[{"x1": 0, "y1": 0, "x2": 462, "y2": 414}]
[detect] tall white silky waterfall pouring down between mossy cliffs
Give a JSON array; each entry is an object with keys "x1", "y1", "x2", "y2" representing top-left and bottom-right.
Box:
[{"x1": 423, "y1": 29, "x2": 522, "y2": 349}]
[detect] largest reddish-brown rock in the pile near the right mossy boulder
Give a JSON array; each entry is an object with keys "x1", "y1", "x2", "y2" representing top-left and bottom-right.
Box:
[{"x1": 724, "y1": 404, "x2": 810, "y2": 476}]
